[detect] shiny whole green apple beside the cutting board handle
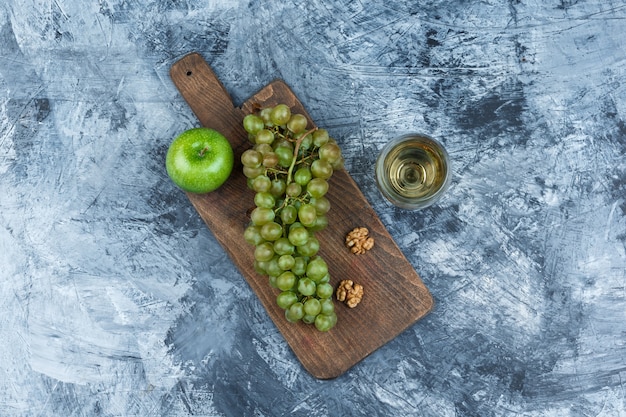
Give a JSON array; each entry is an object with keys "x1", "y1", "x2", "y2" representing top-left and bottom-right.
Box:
[{"x1": 165, "y1": 127, "x2": 235, "y2": 194}]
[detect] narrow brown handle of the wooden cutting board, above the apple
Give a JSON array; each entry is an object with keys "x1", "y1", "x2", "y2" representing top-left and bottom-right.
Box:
[{"x1": 170, "y1": 52, "x2": 245, "y2": 147}]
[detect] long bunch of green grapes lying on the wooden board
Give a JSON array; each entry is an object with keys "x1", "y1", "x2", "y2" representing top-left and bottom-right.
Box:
[{"x1": 241, "y1": 103, "x2": 343, "y2": 332}]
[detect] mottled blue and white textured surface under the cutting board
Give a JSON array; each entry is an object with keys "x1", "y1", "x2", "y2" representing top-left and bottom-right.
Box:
[{"x1": 0, "y1": 0, "x2": 626, "y2": 417}]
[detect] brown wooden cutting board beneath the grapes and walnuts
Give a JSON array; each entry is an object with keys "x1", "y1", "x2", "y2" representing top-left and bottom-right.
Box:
[{"x1": 170, "y1": 53, "x2": 433, "y2": 379}]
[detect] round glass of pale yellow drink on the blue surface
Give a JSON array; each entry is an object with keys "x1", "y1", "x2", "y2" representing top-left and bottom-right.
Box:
[{"x1": 375, "y1": 133, "x2": 452, "y2": 210}]
